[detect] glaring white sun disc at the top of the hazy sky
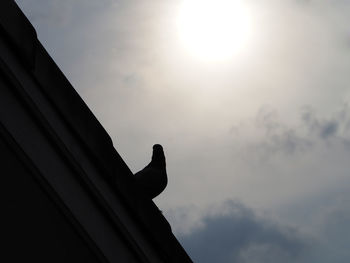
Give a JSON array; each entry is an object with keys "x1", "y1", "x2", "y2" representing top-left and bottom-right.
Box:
[{"x1": 177, "y1": 0, "x2": 251, "y2": 61}]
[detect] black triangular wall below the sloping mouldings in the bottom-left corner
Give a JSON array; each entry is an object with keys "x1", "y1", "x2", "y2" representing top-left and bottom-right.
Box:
[{"x1": 0, "y1": 134, "x2": 104, "y2": 263}]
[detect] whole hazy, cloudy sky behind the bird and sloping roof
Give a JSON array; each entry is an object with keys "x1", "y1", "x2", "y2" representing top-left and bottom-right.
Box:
[{"x1": 16, "y1": 0, "x2": 350, "y2": 263}]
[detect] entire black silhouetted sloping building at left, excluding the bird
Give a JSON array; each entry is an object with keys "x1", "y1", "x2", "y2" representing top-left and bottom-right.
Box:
[{"x1": 0, "y1": 0, "x2": 192, "y2": 263}]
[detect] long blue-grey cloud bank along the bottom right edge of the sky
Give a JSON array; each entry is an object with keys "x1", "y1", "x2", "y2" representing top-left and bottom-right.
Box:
[{"x1": 177, "y1": 195, "x2": 350, "y2": 263}]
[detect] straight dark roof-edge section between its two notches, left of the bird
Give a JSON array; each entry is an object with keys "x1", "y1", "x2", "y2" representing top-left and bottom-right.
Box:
[{"x1": 32, "y1": 41, "x2": 117, "y2": 179}]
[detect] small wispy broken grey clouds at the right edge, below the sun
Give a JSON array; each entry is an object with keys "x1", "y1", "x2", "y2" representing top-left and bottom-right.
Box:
[{"x1": 237, "y1": 103, "x2": 350, "y2": 162}]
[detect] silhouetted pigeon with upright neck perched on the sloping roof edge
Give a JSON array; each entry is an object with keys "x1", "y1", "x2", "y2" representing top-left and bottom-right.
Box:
[{"x1": 134, "y1": 144, "x2": 168, "y2": 199}]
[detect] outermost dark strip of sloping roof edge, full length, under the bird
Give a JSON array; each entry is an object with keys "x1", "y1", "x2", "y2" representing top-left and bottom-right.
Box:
[{"x1": 0, "y1": 0, "x2": 192, "y2": 262}]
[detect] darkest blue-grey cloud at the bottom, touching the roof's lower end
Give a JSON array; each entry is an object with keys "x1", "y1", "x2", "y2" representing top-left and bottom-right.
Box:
[{"x1": 180, "y1": 201, "x2": 307, "y2": 263}]
